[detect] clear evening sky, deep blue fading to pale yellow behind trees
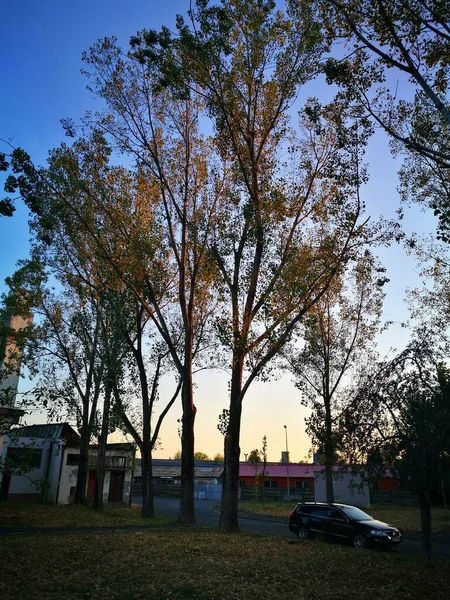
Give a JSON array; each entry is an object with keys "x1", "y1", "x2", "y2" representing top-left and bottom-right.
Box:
[{"x1": 0, "y1": 0, "x2": 435, "y2": 461}]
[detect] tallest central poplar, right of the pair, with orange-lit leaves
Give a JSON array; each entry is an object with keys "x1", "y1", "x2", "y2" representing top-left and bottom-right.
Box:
[{"x1": 131, "y1": 0, "x2": 390, "y2": 531}]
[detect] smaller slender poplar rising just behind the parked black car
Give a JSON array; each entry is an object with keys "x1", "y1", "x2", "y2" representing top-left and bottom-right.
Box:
[{"x1": 284, "y1": 251, "x2": 387, "y2": 503}]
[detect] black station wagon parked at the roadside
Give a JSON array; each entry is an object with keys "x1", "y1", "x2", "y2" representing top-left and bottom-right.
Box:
[{"x1": 289, "y1": 502, "x2": 402, "y2": 548}]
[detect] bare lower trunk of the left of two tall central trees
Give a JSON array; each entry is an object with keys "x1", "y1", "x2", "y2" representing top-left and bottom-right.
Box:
[{"x1": 179, "y1": 364, "x2": 197, "y2": 523}]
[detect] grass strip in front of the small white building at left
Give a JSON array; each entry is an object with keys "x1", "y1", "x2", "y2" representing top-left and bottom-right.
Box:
[{"x1": 0, "y1": 502, "x2": 167, "y2": 528}]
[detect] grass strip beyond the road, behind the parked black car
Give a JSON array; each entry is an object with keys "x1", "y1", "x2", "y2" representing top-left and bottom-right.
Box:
[{"x1": 239, "y1": 501, "x2": 450, "y2": 533}]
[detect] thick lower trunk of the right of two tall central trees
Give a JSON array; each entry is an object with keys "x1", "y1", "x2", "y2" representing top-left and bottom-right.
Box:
[{"x1": 219, "y1": 359, "x2": 244, "y2": 532}]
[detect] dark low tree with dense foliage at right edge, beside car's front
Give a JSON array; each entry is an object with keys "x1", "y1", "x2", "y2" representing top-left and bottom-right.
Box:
[{"x1": 341, "y1": 333, "x2": 450, "y2": 560}]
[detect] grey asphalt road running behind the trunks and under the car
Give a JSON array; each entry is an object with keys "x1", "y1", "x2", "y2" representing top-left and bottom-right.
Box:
[{"x1": 133, "y1": 498, "x2": 450, "y2": 558}]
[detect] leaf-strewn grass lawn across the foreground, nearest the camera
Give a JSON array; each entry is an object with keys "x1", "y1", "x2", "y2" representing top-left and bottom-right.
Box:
[{"x1": 0, "y1": 528, "x2": 450, "y2": 600}]
